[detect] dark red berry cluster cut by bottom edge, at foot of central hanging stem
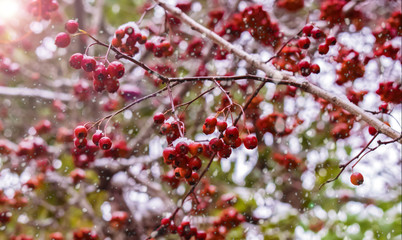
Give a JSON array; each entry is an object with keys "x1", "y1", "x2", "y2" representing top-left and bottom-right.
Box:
[{"x1": 161, "y1": 218, "x2": 207, "y2": 240}]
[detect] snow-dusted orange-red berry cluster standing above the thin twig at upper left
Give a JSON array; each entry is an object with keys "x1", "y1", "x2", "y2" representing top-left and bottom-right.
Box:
[{"x1": 112, "y1": 23, "x2": 147, "y2": 56}]
